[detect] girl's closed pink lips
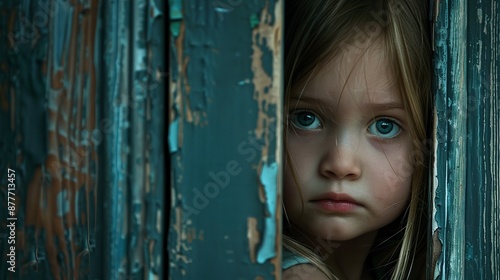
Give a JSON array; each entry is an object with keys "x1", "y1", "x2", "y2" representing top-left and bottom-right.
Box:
[{"x1": 310, "y1": 192, "x2": 361, "y2": 213}]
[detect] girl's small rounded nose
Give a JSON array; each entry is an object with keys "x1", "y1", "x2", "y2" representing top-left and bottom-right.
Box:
[{"x1": 319, "y1": 137, "x2": 363, "y2": 180}]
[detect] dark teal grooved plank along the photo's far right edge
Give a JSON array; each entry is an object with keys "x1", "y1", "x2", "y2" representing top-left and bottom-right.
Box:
[{"x1": 465, "y1": 1, "x2": 500, "y2": 279}]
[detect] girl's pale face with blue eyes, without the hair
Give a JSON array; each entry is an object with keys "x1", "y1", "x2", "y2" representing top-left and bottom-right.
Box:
[{"x1": 284, "y1": 44, "x2": 413, "y2": 241}]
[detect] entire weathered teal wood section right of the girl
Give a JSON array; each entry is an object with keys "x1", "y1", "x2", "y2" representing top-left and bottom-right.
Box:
[{"x1": 432, "y1": 1, "x2": 500, "y2": 279}]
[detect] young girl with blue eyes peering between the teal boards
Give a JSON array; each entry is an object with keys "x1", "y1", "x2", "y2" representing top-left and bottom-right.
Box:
[{"x1": 283, "y1": 0, "x2": 431, "y2": 280}]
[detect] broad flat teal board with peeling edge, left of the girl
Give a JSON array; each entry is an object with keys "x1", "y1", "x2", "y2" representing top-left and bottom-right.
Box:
[{"x1": 168, "y1": 0, "x2": 283, "y2": 279}]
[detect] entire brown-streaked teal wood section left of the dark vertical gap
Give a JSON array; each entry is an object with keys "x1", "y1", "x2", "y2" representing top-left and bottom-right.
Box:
[{"x1": 0, "y1": 0, "x2": 168, "y2": 279}]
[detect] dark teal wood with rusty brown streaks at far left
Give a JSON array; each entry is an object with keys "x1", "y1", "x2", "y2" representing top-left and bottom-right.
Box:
[{"x1": 1, "y1": 0, "x2": 102, "y2": 279}]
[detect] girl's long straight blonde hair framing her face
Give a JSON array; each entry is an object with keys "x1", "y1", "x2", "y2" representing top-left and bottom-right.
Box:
[{"x1": 283, "y1": 0, "x2": 431, "y2": 279}]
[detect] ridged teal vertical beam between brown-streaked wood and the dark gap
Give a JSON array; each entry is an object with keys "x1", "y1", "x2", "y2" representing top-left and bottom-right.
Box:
[{"x1": 102, "y1": 0, "x2": 168, "y2": 279}]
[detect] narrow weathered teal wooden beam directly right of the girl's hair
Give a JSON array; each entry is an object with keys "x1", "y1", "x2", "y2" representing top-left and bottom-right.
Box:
[{"x1": 433, "y1": 1, "x2": 467, "y2": 279}]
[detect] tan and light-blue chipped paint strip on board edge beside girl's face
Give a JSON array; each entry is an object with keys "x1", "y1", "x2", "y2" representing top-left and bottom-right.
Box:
[{"x1": 250, "y1": 1, "x2": 283, "y2": 278}]
